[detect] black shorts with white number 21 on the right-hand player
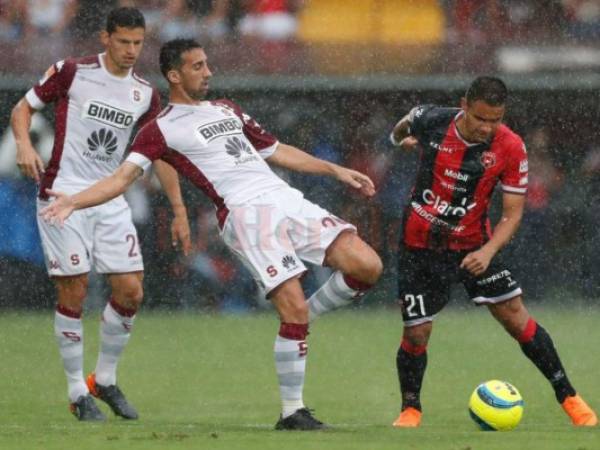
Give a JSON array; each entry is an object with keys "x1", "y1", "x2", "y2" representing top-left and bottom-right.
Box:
[{"x1": 398, "y1": 245, "x2": 521, "y2": 326}]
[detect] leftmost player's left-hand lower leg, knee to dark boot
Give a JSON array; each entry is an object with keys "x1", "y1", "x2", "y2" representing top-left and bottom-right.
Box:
[{"x1": 53, "y1": 273, "x2": 106, "y2": 421}]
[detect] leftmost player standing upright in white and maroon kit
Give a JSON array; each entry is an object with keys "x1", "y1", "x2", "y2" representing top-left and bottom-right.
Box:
[{"x1": 11, "y1": 8, "x2": 190, "y2": 420}]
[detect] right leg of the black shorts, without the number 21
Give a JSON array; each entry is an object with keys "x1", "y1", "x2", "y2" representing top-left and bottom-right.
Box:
[{"x1": 463, "y1": 254, "x2": 522, "y2": 305}]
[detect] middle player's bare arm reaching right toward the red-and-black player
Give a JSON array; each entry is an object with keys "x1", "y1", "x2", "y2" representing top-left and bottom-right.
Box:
[{"x1": 267, "y1": 144, "x2": 375, "y2": 197}]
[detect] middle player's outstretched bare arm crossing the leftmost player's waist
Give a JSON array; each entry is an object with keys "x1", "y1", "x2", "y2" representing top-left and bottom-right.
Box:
[{"x1": 40, "y1": 161, "x2": 143, "y2": 226}]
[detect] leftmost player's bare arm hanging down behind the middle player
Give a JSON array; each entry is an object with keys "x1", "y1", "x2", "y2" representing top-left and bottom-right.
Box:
[{"x1": 154, "y1": 160, "x2": 192, "y2": 256}]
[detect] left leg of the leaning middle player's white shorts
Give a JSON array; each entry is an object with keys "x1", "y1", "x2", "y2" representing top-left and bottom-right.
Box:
[{"x1": 221, "y1": 204, "x2": 306, "y2": 296}]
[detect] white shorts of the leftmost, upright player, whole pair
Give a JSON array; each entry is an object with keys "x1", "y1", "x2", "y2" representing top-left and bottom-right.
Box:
[{"x1": 37, "y1": 197, "x2": 144, "y2": 276}]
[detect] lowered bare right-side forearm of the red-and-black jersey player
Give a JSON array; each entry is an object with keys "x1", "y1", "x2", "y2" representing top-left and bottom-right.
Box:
[{"x1": 461, "y1": 193, "x2": 525, "y2": 275}]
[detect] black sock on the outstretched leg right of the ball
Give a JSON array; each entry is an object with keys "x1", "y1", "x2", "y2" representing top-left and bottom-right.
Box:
[{"x1": 520, "y1": 319, "x2": 575, "y2": 403}]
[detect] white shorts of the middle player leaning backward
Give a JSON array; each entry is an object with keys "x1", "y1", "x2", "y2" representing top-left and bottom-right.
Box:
[{"x1": 221, "y1": 188, "x2": 356, "y2": 294}]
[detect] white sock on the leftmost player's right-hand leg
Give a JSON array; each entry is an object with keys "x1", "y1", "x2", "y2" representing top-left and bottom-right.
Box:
[{"x1": 96, "y1": 303, "x2": 135, "y2": 386}]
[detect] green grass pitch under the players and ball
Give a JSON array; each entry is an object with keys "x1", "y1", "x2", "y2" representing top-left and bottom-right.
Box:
[{"x1": 0, "y1": 305, "x2": 600, "y2": 450}]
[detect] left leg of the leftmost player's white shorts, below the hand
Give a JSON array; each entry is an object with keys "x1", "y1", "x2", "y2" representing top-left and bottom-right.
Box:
[{"x1": 36, "y1": 200, "x2": 93, "y2": 277}]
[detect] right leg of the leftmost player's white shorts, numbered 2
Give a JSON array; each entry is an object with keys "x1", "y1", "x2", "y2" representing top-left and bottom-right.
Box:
[{"x1": 93, "y1": 202, "x2": 144, "y2": 274}]
